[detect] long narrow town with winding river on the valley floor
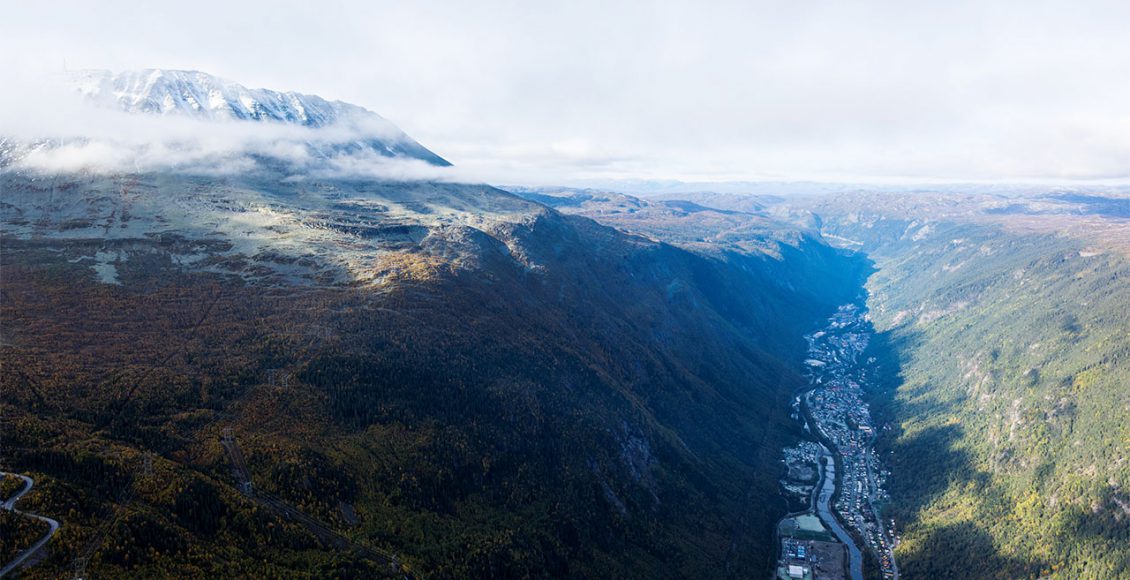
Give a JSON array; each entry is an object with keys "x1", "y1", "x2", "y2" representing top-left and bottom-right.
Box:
[{"x1": 775, "y1": 304, "x2": 898, "y2": 580}]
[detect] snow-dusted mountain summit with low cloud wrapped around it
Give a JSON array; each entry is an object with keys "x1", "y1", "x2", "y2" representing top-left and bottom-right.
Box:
[{"x1": 0, "y1": 69, "x2": 451, "y2": 179}]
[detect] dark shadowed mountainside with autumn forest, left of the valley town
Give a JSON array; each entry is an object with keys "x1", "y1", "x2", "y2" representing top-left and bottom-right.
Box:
[{"x1": 0, "y1": 170, "x2": 864, "y2": 578}]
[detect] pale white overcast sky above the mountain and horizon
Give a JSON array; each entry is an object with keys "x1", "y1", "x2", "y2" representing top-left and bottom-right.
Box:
[{"x1": 0, "y1": 0, "x2": 1130, "y2": 184}]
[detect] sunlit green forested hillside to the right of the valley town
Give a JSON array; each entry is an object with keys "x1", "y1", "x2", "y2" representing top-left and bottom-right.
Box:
[{"x1": 807, "y1": 194, "x2": 1130, "y2": 578}]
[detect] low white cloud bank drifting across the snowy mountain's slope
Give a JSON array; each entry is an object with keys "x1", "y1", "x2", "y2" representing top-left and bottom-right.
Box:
[{"x1": 0, "y1": 72, "x2": 471, "y2": 181}]
